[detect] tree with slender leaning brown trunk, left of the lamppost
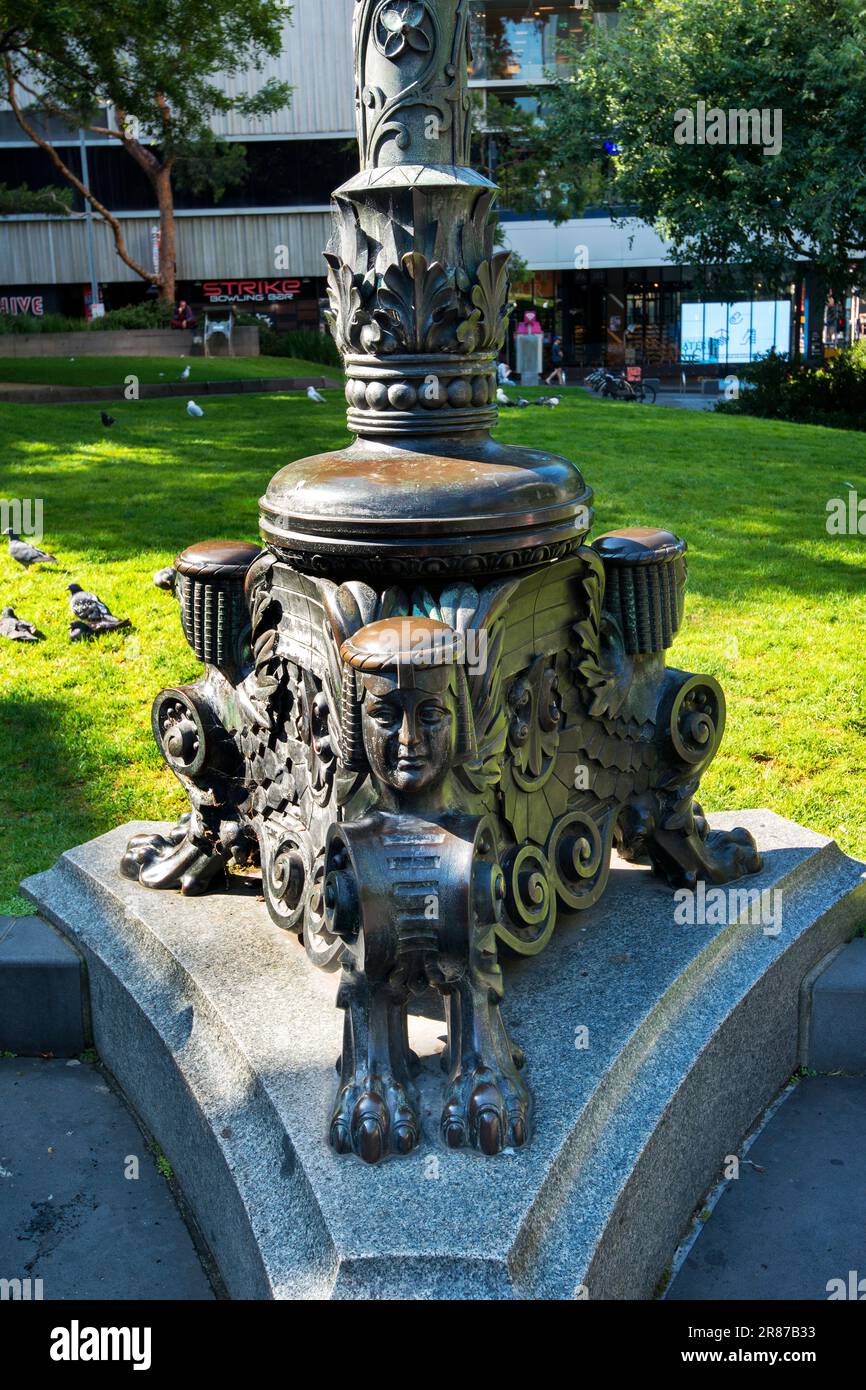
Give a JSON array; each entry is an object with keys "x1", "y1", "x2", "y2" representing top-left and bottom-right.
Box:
[{"x1": 0, "y1": 0, "x2": 291, "y2": 300}]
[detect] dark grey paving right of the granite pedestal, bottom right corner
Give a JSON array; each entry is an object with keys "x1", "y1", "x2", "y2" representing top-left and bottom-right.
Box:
[{"x1": 667, "y1": 1076, "x2": 866, "y2": 1301}]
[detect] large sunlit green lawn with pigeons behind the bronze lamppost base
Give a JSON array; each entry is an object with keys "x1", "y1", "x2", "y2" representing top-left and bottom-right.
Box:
[{"x1": 0, "y1": 389, "x2": 866, "y2": 912}]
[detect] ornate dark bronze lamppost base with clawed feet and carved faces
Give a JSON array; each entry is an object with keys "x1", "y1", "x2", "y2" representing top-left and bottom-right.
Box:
[{"x1": 124, "y1": 0, "x2": 760, "y2": 1162}]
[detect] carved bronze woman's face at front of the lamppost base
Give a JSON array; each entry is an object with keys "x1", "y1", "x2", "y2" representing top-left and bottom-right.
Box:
[{"x1": 361, "y1": 670, "x2": 457, "y2": 796}]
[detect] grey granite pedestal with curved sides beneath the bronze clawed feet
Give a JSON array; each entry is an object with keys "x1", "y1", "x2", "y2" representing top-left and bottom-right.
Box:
[{"x1": 24, "y1": 810, "x2": 866, "y2": 1300}]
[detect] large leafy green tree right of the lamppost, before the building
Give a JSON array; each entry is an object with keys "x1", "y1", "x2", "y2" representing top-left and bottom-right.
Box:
[{"x1": 545, "y1": 0, "x2": 866, "y2": 291}]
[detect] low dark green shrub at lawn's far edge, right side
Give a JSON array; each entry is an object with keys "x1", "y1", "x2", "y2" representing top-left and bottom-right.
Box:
[{"x1": 716, "y1": 343, "x2": 866, "y2": 430}]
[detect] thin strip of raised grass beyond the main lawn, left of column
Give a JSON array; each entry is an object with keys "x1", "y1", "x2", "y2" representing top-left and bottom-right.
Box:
[{"x1": 0, "y1": 357, "x2": 339, "y2": 399}]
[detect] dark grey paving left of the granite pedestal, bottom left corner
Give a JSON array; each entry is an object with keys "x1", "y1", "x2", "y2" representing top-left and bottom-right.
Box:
[{"x1": 0, "y1": 1058, "x2": 214, "y2": 1300}]
